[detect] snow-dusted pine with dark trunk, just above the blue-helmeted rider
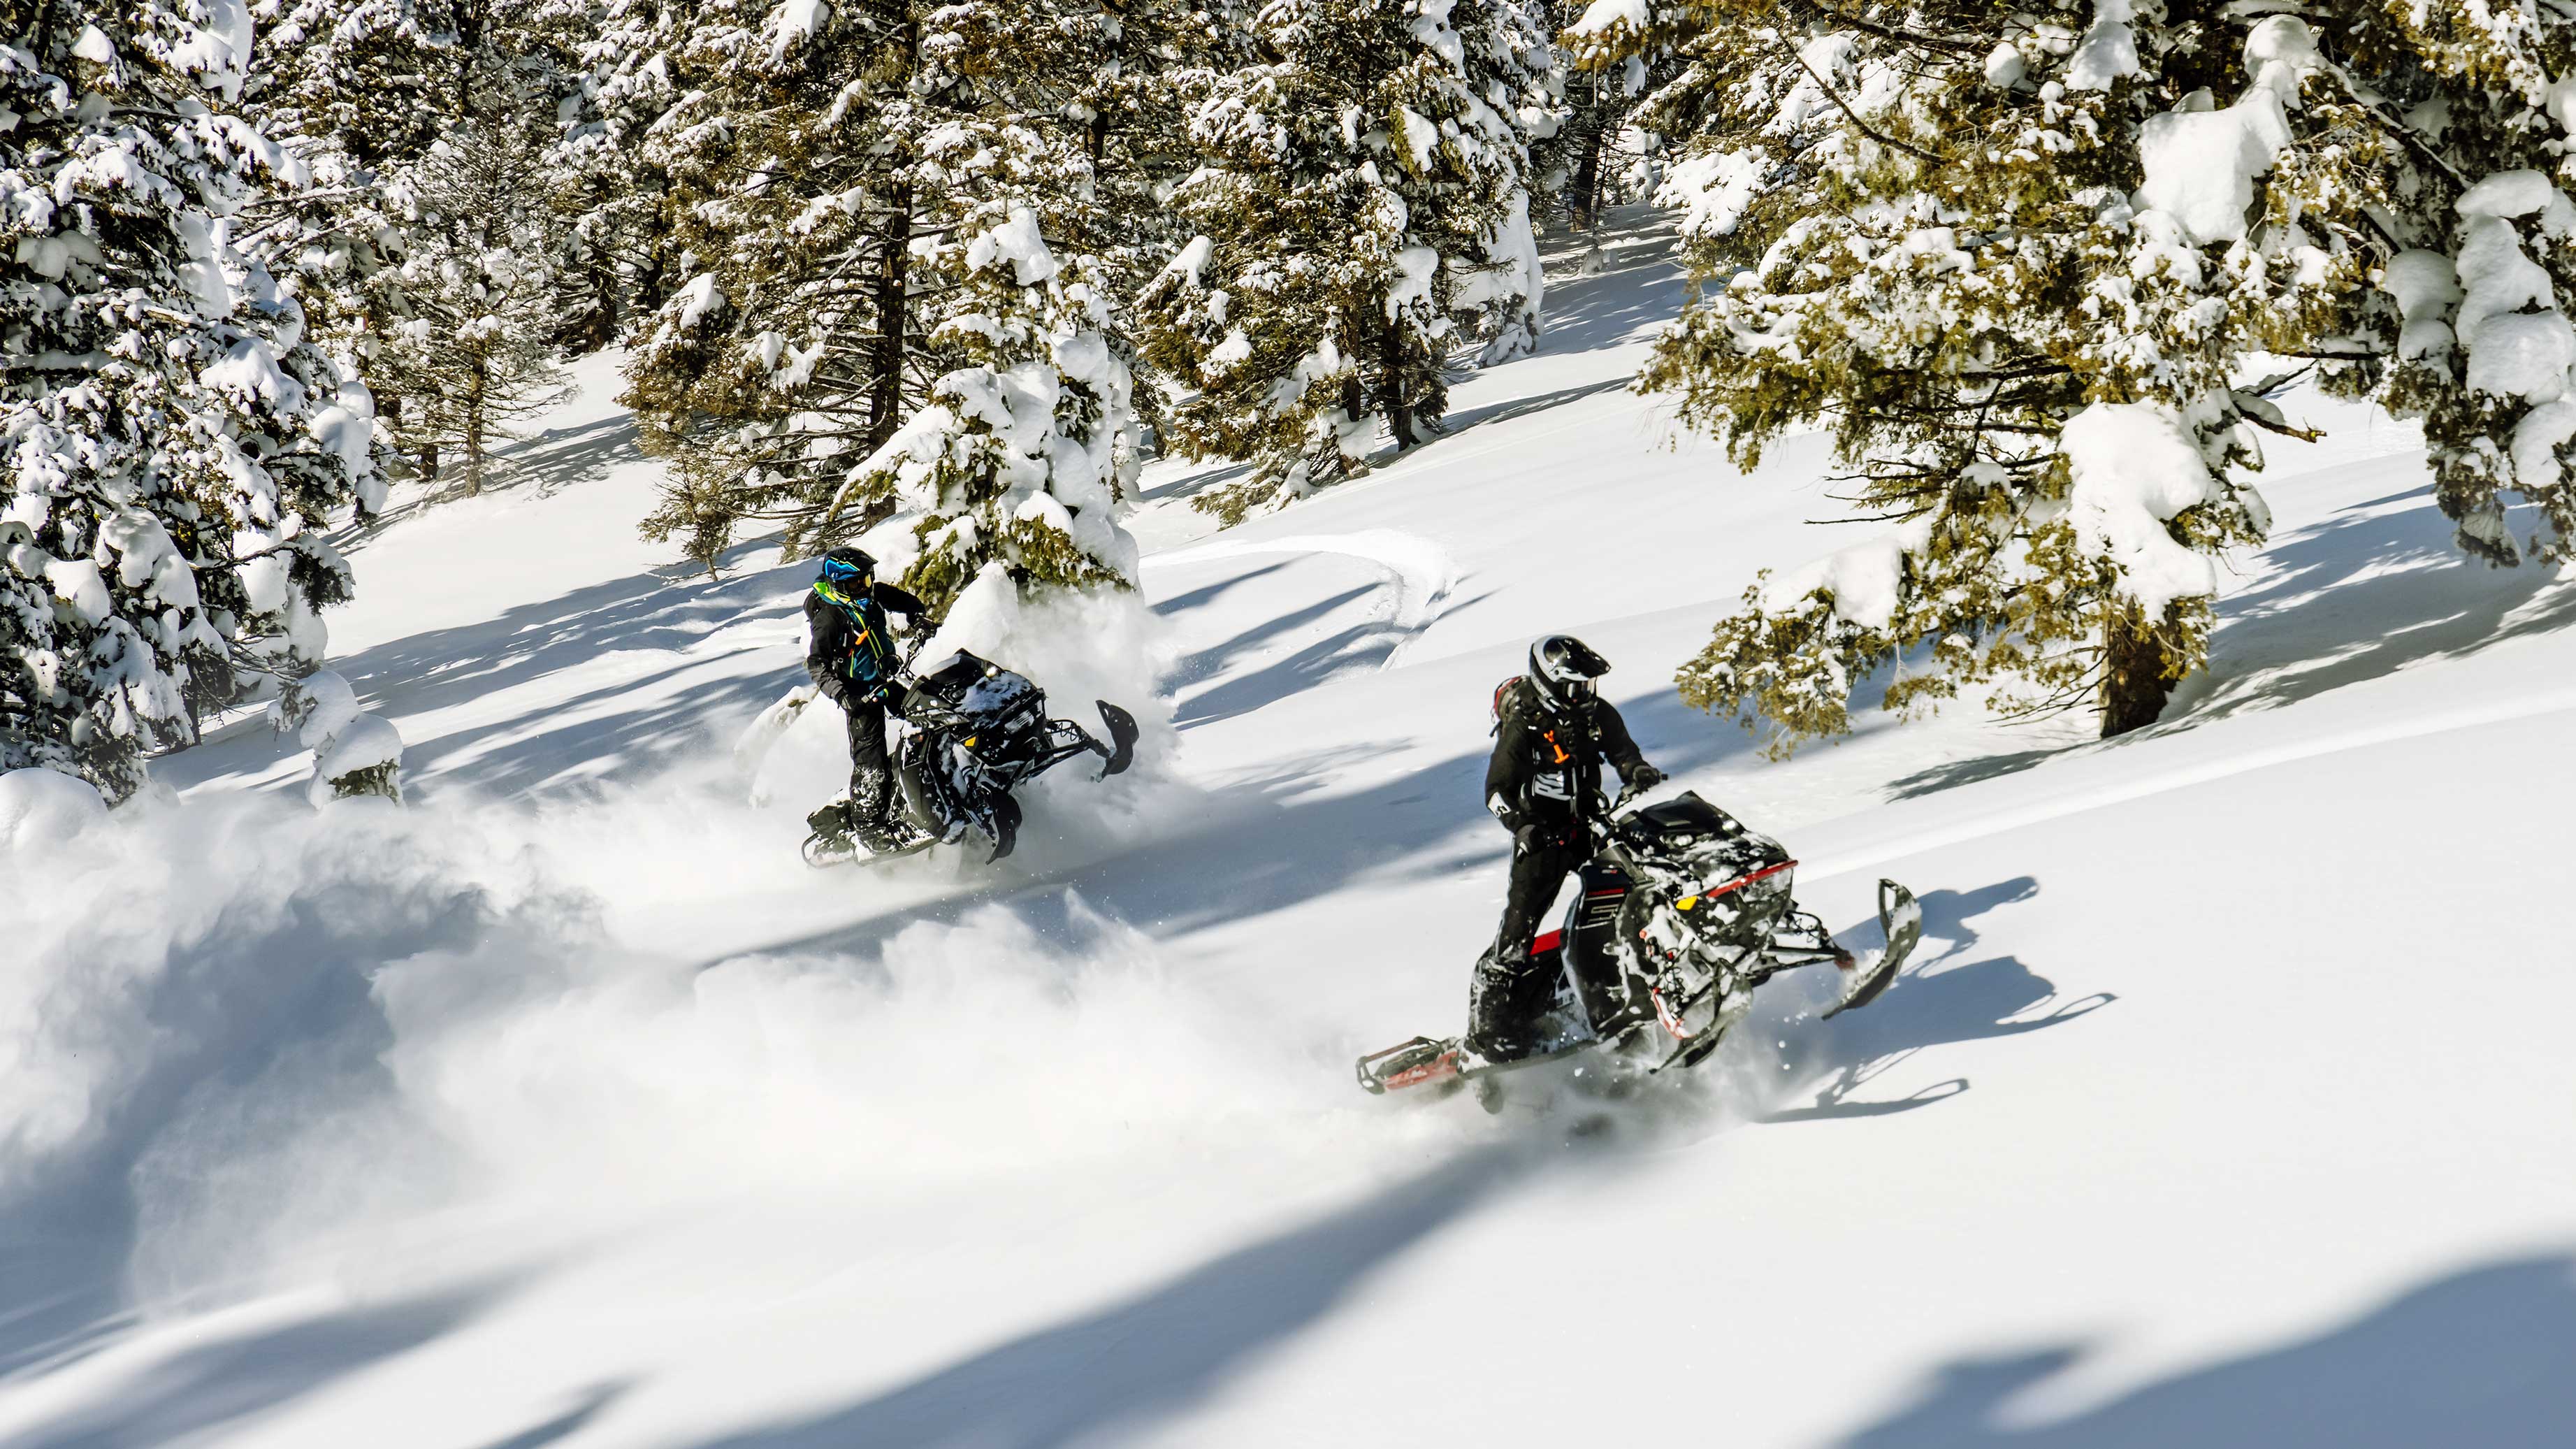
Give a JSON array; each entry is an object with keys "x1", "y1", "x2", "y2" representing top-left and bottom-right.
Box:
[{"x1": 623, "y1": 0, "x2": 927, "y2": 570}]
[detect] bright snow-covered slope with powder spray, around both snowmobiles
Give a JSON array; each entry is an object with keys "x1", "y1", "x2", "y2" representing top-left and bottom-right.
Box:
[{"x1": 0, "y1": 216, "x2": 2576, "y2": 1449}]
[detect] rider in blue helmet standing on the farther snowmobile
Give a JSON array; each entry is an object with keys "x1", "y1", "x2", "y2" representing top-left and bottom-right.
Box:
[{"x1": 806, "y1": 547, "x2": 930, "y2": 853}]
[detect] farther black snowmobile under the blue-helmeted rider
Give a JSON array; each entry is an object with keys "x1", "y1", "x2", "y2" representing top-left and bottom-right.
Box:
[{"x1": 894, "y1": 650, "x2": 1136, "y2": 861}]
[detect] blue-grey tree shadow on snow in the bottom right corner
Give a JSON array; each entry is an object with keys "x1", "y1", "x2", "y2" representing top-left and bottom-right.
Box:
[{"x1": 1841, "y1": 1253, "x2": 2576, "y2": 1449}]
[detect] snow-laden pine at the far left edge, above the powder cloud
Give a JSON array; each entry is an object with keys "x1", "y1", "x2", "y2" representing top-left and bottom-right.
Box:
[{"x1": 0, "y1": 0, "x2": 376, "y2": 799}]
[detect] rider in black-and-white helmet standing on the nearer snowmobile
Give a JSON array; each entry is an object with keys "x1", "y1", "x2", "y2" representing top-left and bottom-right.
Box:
[{"x1": 1466, "y1": 634, "x2": 1664, "y2": 1062}]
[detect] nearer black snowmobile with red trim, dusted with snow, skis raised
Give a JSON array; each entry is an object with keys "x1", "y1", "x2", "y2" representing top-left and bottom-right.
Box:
[{"x1": 1358, "y1": 791, "x2": 1922, "y2": 1106}]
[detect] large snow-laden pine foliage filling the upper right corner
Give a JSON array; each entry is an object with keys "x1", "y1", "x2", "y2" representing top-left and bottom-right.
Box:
[{"x1": 1566, "y1": 0, "x2": 2576, "y2": 745}]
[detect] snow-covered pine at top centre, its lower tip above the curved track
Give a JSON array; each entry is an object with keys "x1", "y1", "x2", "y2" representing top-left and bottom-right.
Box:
[{"x1": 1138, "y1": 0, "x2": 1556, "y2": 521}]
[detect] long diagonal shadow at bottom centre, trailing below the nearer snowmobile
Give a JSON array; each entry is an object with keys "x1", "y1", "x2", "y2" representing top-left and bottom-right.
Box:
[{"x1": 674, "y1": 1147, "x2": 1512, "y2": 1449}]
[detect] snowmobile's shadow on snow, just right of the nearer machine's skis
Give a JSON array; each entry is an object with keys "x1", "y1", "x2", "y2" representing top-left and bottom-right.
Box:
[{"x1": 1746, "y1": 877, "x2": 2118, "y2": 1122}]
